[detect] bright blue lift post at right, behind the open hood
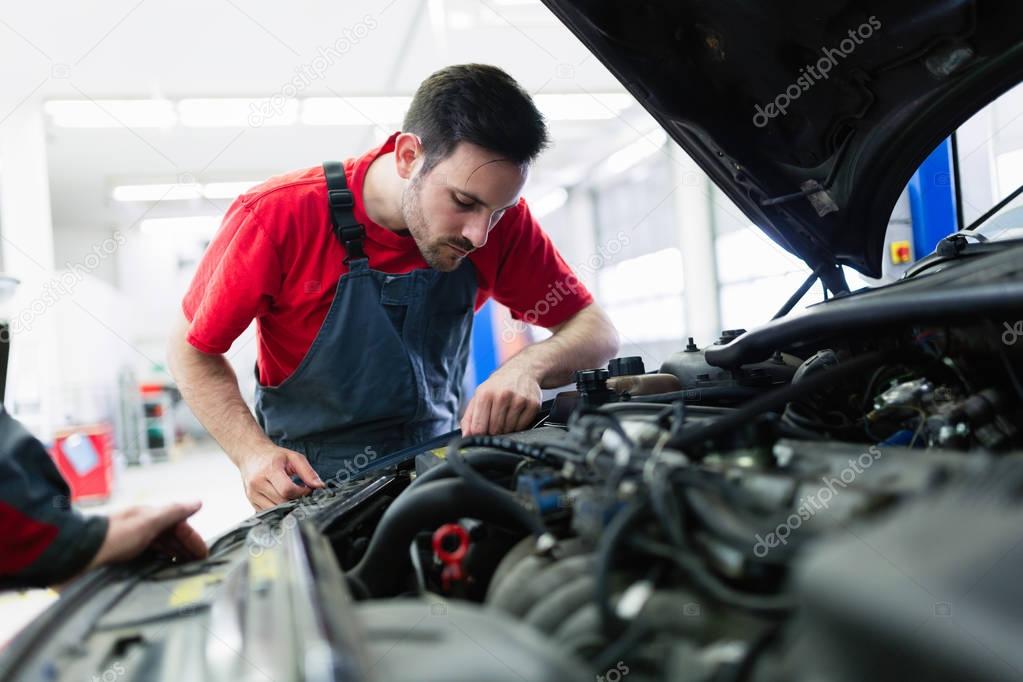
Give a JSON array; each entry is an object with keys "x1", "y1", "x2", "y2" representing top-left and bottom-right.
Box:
[{"x1": 908, "y1": 139, "x2": 960, "y2": 261}]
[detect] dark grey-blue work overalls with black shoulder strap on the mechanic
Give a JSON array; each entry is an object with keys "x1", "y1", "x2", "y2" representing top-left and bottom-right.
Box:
[{"x1": 256, "y1": 162, "x2": 477, "y2": 481}]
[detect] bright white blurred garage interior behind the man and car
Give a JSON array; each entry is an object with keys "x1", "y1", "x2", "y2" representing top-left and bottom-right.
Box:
[{"x1": 0, "y1": 0, "x2": 1023, "y2": 647}]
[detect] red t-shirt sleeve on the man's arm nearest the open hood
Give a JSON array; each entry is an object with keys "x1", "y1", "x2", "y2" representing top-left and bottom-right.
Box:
[{"x1": 493, "y1": 200, "x2": 593, "y2": 327}]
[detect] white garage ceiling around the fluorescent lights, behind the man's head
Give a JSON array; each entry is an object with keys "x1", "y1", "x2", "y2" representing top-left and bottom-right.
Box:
[{"x1": 0, "y1": 0, "x2": 652, "y2": 235}]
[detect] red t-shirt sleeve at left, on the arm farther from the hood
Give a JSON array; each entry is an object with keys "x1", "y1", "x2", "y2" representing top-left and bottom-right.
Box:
[{"x1": 182, "y1": 196, "x2": 282, "y2": 353}]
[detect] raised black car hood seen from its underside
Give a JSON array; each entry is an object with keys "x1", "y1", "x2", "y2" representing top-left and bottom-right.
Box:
[{"x1": 543, "y1": 0, "x2": 1023, "y2": 276}]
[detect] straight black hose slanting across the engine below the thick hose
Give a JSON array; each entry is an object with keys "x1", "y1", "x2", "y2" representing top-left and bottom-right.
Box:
[{"x1": 671, "y1": 353, "x2": 891, "y2": 450}]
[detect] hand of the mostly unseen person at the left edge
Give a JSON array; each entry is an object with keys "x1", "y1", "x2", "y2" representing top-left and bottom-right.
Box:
[{"x1": 86, "y1": 502, "x2": 209, "y2": 570}]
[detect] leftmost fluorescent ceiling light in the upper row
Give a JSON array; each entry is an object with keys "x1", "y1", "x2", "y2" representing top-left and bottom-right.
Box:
[{"x1": 43, "y1": 99, "x2": 177, "y2": 128}]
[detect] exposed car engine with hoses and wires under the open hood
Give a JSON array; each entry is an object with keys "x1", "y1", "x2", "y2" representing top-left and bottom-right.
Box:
[{"x1": 317, "y1": 242, "x2": 1023, "y2": 680}]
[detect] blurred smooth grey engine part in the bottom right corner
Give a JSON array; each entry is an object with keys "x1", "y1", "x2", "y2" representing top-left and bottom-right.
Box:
[{"x1": 773, "y1": 461, "x2": 1023, "y2": 682}]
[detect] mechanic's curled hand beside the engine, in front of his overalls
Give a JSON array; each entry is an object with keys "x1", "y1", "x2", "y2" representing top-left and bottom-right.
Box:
[{"x1": 461, "y1": 365, "x2": 541, "y2": 436}]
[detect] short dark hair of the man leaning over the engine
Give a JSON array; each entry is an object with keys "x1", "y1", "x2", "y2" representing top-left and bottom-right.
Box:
[{"x1": 402, "y1": 64, "x2": 549, "y2": 173}]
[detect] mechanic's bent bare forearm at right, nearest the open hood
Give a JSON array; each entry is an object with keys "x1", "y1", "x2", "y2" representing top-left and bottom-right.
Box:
[{"x1": 504, "y1": 304, "x2": 618, "y2": 389}]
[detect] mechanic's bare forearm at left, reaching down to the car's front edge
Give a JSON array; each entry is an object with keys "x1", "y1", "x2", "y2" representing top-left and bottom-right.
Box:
[{"x1": 169, "y1": 318, "x2": 270, "y2": 466}]
